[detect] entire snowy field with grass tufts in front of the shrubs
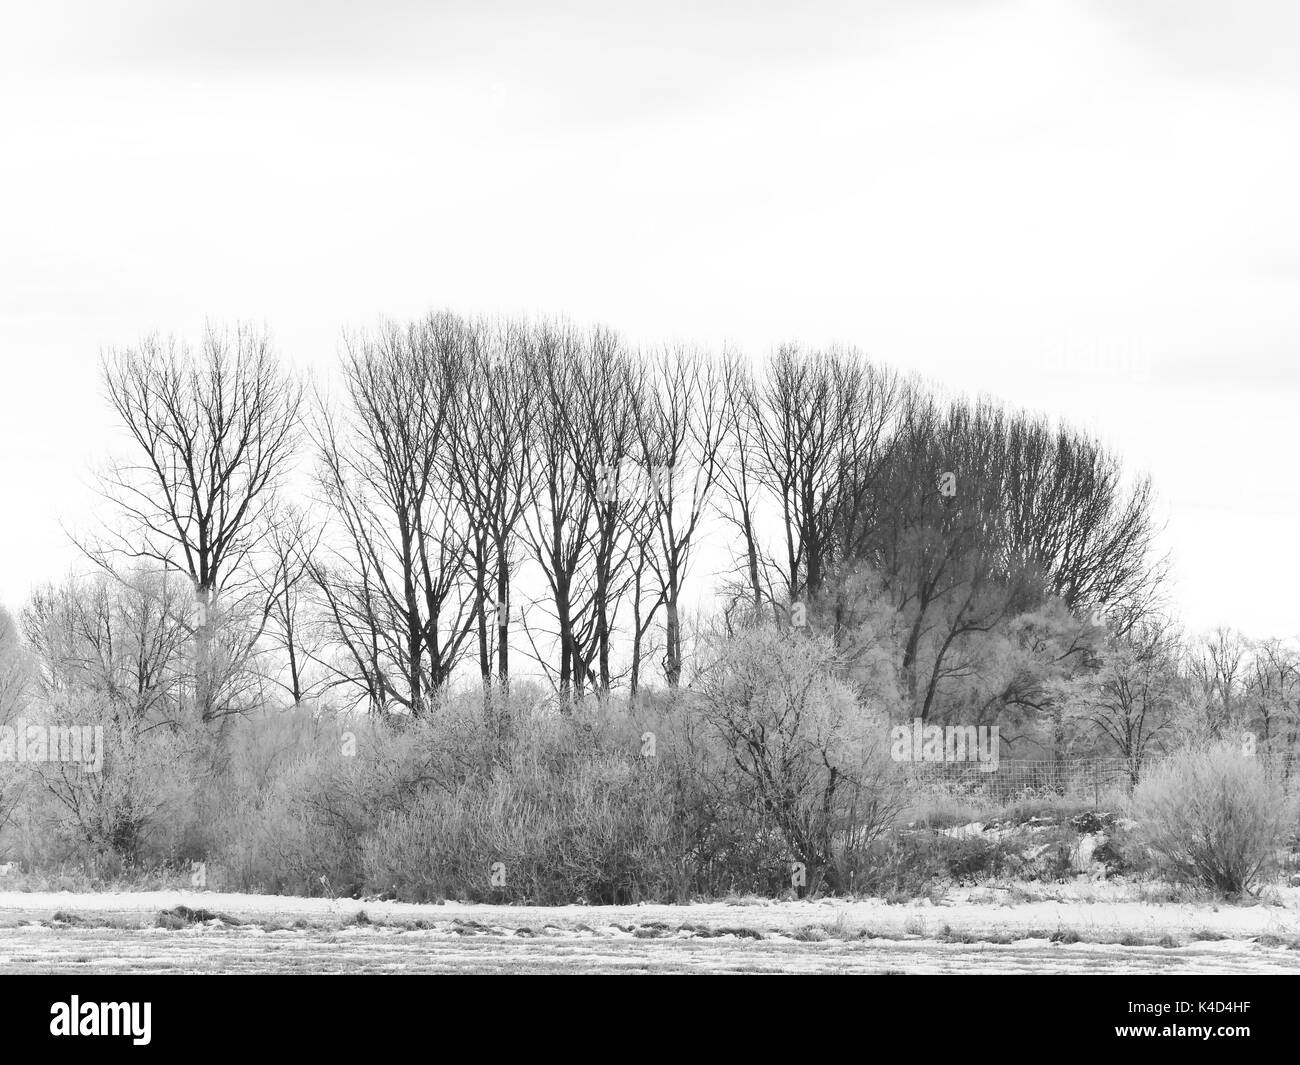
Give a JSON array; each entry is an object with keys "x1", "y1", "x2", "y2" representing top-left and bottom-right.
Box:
[{"x1": 0, "y1": 882, "x2": 1300, "y2": 974}]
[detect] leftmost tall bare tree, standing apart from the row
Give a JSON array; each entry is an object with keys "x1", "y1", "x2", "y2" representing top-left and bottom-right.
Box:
[{"x1": 90, "y1": 326, "x2": 303, "y2": 720}]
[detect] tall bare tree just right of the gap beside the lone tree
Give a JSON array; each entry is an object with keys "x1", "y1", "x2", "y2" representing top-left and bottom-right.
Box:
[{"x1": 312, "y1": 315, "x2": 480, "y2": 715}]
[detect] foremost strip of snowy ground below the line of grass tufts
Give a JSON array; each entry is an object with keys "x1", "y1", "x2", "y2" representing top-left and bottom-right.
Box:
[{"x1": 0, "y1": 927, "x2": 1300, "y2": 975}]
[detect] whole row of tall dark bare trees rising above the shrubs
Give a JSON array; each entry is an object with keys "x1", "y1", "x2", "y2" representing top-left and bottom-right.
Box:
[{"x1": 20, "y1": 313, "x2": 1161, "y2": 738}]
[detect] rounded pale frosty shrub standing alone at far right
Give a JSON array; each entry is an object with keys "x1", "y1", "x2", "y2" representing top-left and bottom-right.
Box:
[{"x1": 1134, "y1": 745, "x2": 1287, "y2": 895}]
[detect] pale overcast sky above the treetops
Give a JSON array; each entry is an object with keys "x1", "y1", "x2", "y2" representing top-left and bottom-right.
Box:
[{"x1": 0, "y1": 0, "x2": 1300, "y2": 636}]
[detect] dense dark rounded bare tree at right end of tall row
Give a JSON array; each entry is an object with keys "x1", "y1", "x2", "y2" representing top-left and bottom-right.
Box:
[{"x1": 831, "y1": 384, "x2": 1158, "y2": 718}]
